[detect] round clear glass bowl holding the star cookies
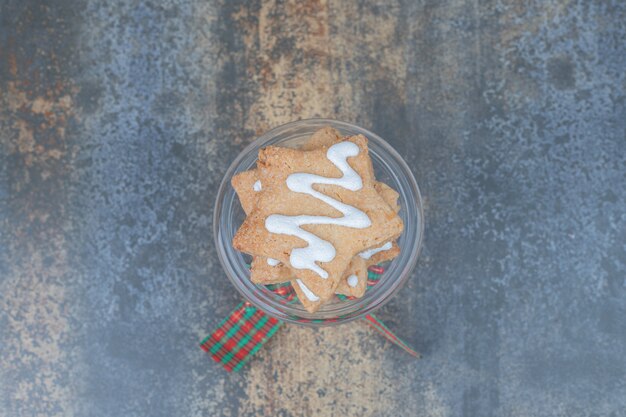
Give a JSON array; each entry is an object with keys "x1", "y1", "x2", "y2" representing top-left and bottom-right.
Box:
[{"x1": 213, "y1": 119, "x2": 424, "y2": 326}]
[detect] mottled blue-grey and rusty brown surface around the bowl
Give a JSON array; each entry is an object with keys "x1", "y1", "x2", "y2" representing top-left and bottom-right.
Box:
[{"x1": 0, "y1": 0, "x2": 626, "y2": 417}]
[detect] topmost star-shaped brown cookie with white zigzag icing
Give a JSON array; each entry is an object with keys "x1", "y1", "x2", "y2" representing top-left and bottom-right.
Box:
[{"x1": 233, "y1": 135, "x2": 402, "y2": 301}]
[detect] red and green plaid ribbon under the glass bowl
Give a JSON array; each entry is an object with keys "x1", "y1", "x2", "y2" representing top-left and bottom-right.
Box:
[{"x1": 200, "y1": 266, "x2": 420, "y2": 372}]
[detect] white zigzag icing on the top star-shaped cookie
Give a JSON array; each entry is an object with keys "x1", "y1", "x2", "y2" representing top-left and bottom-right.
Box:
[{"x1": 265, "y1": 141, "x2": 372, "y2": 280}]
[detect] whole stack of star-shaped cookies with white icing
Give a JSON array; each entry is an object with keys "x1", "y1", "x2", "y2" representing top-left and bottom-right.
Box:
[{"x1": 232, "y1": 127, "x2": 403, "y2": 312}]
